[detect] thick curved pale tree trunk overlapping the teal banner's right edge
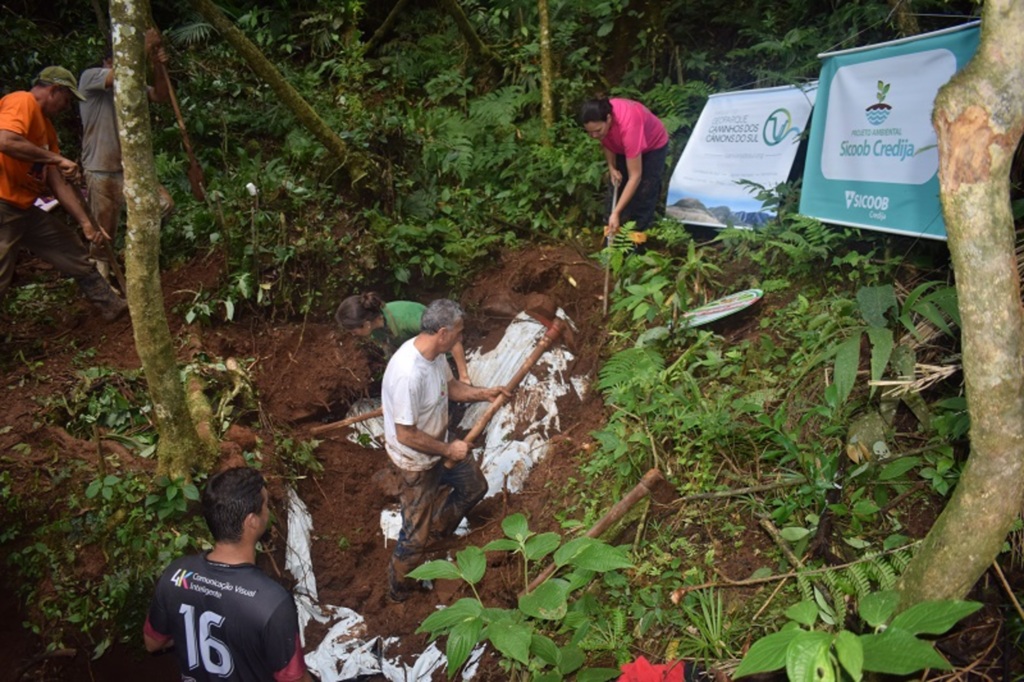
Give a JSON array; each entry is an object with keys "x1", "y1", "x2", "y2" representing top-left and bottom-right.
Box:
[{"x1": 899, "y1": 0, "x2": 1024, "y2": 608}]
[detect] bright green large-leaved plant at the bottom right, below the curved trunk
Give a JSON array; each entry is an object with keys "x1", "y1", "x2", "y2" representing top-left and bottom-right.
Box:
[{"x1": 733, "y1": 591, "x2": 981, "y2": 682}]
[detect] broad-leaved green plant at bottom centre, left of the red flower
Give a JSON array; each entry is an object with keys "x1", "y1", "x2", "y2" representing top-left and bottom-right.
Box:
[{"x1": 409, "y1": 514, "x2": 632, "y2": 680}]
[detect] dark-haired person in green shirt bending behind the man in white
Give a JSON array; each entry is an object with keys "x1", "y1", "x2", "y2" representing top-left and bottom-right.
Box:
[{"x1": 334, "y1": 291, "x2": 472, "y2": 378}]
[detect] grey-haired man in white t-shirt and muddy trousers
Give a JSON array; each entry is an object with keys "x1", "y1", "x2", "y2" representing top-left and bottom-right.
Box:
[{"x1": 381, "y1": 299, "x2": 507, "y2": 602}]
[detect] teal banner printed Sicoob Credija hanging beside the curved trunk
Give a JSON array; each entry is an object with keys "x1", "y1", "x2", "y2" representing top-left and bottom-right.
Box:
[{"x1": 800, "y1": 23, "x2": 979, "y2": 240}]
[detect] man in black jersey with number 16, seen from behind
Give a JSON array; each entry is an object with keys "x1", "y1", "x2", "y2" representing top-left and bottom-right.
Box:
[{"x1": 142, "y1": 467, "x2": 311, "y2": 682}]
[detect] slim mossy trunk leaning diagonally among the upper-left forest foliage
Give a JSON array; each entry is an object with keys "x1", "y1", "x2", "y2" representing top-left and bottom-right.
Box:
[{"x1": 188, "y1": 0, "x2": 377, "y2": 189}]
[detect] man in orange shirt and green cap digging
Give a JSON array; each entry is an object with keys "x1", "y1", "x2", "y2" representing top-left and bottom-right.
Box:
[{"x1": 0, "y1": 67, "x2": 128, "y2": 322}]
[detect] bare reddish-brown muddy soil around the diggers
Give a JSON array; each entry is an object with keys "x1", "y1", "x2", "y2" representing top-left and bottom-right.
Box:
[{"x1": 0, "y1": 241, "x2": 1011, "y2": 682}]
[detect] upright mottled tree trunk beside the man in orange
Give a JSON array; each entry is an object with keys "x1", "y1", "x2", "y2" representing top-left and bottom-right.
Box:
[{"x1": 111, "y1": 0, "x2": 216, "y2": 479}]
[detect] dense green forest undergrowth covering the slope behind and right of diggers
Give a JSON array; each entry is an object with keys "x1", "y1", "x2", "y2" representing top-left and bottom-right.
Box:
[{"x1": 6, "y1": 0, "x2": 1021, "y2": 679}]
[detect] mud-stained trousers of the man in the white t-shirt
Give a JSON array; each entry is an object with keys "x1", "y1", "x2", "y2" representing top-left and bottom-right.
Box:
[{"x1": 388, "y1": 457, "x2": 487, "y2": 592}]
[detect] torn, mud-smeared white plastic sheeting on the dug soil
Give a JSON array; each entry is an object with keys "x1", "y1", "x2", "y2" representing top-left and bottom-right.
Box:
[{"x1": 286, "y1": 310, "x2": 588, "y2": 682}]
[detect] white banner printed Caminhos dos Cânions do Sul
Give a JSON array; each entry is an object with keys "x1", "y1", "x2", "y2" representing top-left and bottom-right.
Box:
[{"x1": 665, "y1": 82, "x2": 817, "y2": 227}]
